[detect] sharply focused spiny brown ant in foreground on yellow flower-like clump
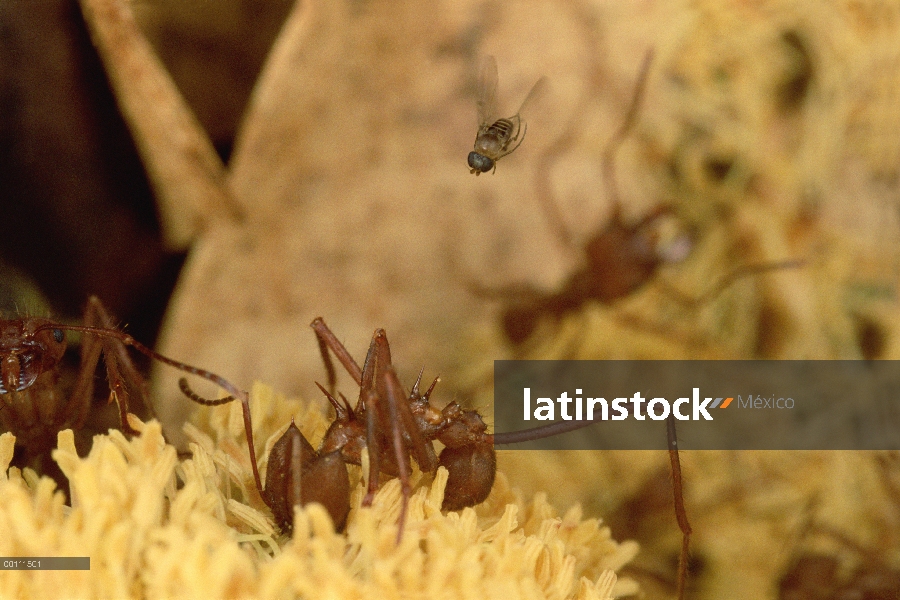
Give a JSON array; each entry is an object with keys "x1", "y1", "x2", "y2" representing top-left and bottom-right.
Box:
[{"x1": 180, "y1": 318, "x2": 691, "y2": 598}]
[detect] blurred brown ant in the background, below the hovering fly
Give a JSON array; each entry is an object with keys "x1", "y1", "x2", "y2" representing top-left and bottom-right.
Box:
[{"x1": 469, "y1": 51, "x2": 803, "y2": 346}]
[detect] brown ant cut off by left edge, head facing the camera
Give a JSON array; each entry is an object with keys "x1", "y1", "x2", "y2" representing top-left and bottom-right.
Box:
[{"x1": 0, "y1": 296, "x2": 248, "y2": 478}]
